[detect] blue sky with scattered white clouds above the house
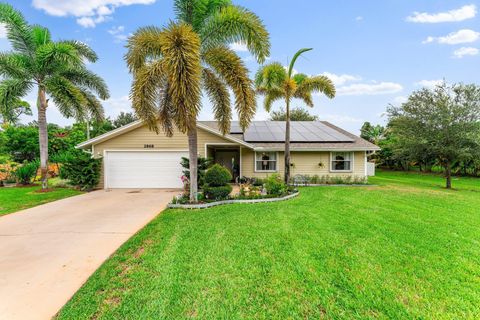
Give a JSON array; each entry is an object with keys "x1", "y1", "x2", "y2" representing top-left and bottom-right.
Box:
[{"x1": 0, "y1": 0, "x2": 480, "y2": 132}]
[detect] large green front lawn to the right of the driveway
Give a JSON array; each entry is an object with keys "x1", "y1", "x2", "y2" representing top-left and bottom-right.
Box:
[{"x1": 58, "y1": 172, "x2": 480, "y2": 319}]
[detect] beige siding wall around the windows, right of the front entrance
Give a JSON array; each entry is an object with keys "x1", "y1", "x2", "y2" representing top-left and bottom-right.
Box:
[{"x1": 241, "y1": 148, "x2": 365, "y2": 178}]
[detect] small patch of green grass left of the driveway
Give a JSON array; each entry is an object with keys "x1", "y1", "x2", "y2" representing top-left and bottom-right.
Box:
[{"x1": 0, "y1": 181, "x2": 81, "y2": 216}]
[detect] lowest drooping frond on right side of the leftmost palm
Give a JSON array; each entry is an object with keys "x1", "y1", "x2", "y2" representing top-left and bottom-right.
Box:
[{"x1": 45, "y1": 76, "x2": 88, "y2": 121}]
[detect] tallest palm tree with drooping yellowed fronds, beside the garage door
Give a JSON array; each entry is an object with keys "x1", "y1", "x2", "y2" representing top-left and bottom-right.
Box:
[{"x1": 125, "y1": 0, "x2": 270, "y2": 201}]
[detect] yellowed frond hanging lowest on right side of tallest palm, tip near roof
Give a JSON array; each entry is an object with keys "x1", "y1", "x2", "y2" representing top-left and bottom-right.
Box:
[{"x1": 203, "y1": 47, "x2": 256, "y2": 129}]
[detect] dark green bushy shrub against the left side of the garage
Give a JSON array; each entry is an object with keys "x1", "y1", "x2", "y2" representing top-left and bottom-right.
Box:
[{"x1": 60, "y1": 151, "x2": 102, "y2": 191}]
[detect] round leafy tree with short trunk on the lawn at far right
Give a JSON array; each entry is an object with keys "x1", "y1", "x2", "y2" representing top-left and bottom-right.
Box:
[{"x1": 388, "y1": 82, "x2": 480, "y2": 189}]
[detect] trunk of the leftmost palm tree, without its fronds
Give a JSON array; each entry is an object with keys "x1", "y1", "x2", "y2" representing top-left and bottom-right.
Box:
[{"x1": 37, "y1": 86, "x2": 48, "y2": 190}]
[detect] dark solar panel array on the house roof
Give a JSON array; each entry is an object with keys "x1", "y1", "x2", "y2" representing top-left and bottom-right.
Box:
[{"x1": 242, "y1": 121, "x2": 354, "y2": 142}]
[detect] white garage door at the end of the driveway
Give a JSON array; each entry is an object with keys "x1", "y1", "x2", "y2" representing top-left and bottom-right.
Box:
[{"x1": 105, "y1": 151, "x2": 188, "y2": 188}]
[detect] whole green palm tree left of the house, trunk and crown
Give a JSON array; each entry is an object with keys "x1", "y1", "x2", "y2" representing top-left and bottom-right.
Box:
[{"x1": 0, "y1": 3, "x2": 109, "y2": 190}]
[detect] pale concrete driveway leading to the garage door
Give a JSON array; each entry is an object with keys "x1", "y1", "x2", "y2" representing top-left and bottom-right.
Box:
[{"x1": 0, "y1": 189, "x2": 178, "y2": 319}]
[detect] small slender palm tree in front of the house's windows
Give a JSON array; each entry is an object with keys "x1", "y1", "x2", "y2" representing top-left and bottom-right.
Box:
[{"x1": 255, "y1": 48, "x2": 335, "y2": 184}]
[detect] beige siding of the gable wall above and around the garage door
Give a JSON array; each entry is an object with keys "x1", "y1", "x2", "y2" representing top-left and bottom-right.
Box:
[{"x1": 93, "y1": 126, "x2": 231, "y2": 188}]
